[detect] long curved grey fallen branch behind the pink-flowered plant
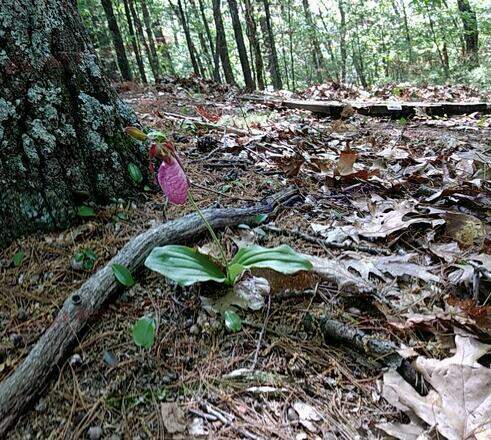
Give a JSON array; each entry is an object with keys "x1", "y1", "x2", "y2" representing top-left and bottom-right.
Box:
[{"x1": 0, "y1": 189, "x2": 297, "y2": 438}]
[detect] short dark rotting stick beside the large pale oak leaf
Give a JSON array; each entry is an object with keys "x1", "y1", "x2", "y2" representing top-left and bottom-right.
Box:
[{"x1": 319, "y1": 315, "x2": 427, "y2": 392}]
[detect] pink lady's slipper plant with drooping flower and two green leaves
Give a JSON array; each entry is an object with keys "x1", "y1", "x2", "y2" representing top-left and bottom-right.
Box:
[{"x1": 126, "y1": 127, "x2": 312, "y2": 336}]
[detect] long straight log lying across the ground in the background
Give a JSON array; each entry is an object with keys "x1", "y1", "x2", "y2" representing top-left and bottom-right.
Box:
[{"x1": 244, "y1": 96, "x2": 491, "y2": 119}]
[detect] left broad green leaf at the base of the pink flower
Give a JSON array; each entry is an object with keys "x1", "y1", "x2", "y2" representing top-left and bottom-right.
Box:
[{"x1": 145, "y1": 245, "x2": 227, "y2": 286}]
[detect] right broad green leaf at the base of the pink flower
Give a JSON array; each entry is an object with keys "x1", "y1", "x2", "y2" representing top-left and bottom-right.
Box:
[{"x1": 230, "y1": 245, "x2": 312, "y2": 275}]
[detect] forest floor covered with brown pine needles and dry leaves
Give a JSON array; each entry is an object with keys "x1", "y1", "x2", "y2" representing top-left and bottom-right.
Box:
[{"x1": 0, "y1": 79, "x2": 491, "y2": 440}]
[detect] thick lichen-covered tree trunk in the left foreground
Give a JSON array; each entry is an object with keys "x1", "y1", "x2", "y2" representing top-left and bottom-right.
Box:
[{"x1": 0, "y1": 0, "x2": 146, "y2": 247}]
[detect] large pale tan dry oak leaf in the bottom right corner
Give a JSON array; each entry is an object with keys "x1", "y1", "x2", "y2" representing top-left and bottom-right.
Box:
[{"x1": 377, "y1": 334, "x2": 491, "y2": 440}]
